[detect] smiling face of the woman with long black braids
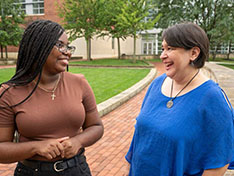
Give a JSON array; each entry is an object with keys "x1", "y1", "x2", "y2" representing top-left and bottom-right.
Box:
[{"x1": 43, "y1": 33, "x2": 71, "y2": 74}]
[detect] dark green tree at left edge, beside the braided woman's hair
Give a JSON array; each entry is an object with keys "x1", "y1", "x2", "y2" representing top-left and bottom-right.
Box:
[{"x1": 0, "y1": 0, "x2": 25, "y2": 58}]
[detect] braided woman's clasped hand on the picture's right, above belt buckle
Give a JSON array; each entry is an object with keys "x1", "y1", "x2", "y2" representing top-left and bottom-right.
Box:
[{"x1": 62, "y1": 138, "x2": 82, "y2": 158}]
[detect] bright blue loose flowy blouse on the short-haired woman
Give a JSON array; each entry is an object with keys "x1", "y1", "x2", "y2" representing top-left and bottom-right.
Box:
[{"x1": 125, "y1": 74, "x2": 234, "y2": 176}]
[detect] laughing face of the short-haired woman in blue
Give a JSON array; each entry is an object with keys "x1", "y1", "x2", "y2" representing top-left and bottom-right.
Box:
[{"x1": 160, "y1": 40, "x2": 195, "y2": 79}]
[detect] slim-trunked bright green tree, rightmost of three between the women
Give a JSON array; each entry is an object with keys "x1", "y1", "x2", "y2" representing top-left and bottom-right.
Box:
[{"x1": 116, "y1": 0, "x2": 160, "y2": 62}]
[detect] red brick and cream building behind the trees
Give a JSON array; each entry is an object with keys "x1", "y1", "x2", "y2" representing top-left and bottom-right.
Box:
[{"x1": 4, "y1": 0, "x2": 159, "y2": 58}]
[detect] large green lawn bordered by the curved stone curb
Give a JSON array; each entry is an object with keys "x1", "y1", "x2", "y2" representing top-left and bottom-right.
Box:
[{"x1": 0, "y1": 67, "x2": 150, "y2": 104}]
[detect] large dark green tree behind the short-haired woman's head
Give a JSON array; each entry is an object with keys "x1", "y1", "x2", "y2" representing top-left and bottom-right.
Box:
[{"x1": 154, "y1": 0, "x2": 233, "y2": 59}]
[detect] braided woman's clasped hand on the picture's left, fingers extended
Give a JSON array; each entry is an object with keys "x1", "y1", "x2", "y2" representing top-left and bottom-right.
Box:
[{"x1": 36, "y1": 137, "x2": 69, "y2": 160}]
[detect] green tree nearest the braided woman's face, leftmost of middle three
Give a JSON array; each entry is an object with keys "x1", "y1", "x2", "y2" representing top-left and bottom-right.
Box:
[{"x1": 59, "y1": 0, "x2": 105, "y2": 60}]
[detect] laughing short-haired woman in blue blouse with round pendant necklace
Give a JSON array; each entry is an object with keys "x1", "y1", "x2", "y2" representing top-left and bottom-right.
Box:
[{"x1": 126, "y1": 23, "x2": 234, "y2": 176}]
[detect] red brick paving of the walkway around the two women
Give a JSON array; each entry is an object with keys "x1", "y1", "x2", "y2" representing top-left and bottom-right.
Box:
[{"x1": 0, "y1": 63, "x2": 164, "y2": 176}]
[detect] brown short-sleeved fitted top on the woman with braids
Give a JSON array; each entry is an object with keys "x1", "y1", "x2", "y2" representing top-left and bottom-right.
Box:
[{"x1": 0, "y1": 72, "x2": 98, "y2": 141}]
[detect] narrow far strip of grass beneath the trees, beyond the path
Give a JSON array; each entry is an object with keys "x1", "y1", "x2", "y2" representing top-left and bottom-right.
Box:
[{"x1": 69, "y1": 59, "x2": 149, "y2": 66}]
